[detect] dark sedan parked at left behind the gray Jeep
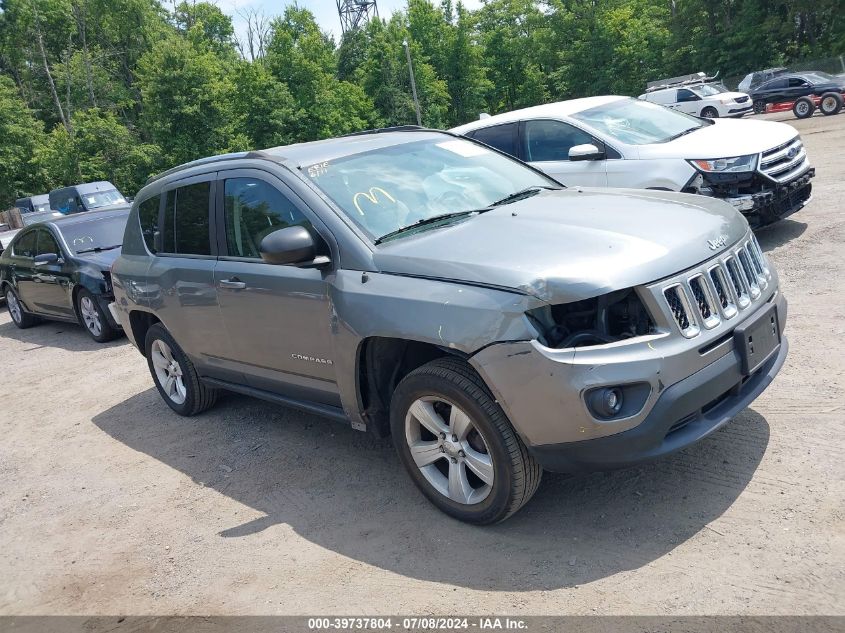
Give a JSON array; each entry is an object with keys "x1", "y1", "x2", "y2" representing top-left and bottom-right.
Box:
[{"x1": 0, "y1": 209, "x2": 129, "y2": 343}]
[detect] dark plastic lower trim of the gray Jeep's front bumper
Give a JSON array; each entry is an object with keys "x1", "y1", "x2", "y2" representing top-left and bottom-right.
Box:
[{"x1": 528, "y1": 336, "x2": 789, "y2": 473}]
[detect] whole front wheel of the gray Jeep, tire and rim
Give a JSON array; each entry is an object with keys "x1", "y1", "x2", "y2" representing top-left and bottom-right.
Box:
[{"x1": 390, "y1": 358, "x2": 542, "y2": 525}]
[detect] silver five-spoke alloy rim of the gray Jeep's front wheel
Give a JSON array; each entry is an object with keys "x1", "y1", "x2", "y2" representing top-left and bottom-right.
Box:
[{"x1": 405, "y1": 396, "x2": 494, "y2": 505}]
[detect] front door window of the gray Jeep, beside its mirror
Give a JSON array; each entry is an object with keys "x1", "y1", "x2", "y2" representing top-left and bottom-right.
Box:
[{"x1": 224, "y1": 178, "x2": 310, "y2": 258}]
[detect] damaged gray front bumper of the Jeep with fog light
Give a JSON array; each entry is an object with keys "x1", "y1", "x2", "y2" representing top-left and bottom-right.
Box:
[{"x1": 470, "y1": 292, "x2": 788, "y2": 472}]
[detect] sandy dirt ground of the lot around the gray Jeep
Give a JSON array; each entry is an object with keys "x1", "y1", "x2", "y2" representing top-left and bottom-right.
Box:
[{"x1": 0, "y1": 114, "x2": 845, "y2": 615}]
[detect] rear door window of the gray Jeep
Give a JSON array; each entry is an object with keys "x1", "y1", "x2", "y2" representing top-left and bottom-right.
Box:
[{"x1": 162, "y1": 182, "x2": 211, "y2": 255}]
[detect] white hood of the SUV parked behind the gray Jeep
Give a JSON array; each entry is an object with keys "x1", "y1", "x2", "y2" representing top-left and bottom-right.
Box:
[{"x1": 637, "y1": 119, "x2": 798, "y2": 159}]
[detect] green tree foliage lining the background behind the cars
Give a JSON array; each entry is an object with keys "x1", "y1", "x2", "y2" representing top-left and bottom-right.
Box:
[{"x1": 0, "y1": 0, "x2": 845, "y2": 208}]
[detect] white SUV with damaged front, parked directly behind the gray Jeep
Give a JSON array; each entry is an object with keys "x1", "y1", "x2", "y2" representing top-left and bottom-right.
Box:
[{"x1": 452, "y1": 96, "x2": 815, "y2": 226}]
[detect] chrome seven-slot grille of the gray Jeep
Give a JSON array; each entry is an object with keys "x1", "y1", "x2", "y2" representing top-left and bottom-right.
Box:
[{"x1": 662, "y1": 234, "x2": 772, "y2": 338}]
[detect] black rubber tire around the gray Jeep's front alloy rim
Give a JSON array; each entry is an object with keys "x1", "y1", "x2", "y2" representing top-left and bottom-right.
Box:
[{"x1": 390, "y1": 358, "x2": 542, "y2": 525}]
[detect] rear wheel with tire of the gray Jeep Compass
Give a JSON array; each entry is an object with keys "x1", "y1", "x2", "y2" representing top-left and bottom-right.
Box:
[{"x1": 144, "y1": 323, "x2": 217, "y2": 416}]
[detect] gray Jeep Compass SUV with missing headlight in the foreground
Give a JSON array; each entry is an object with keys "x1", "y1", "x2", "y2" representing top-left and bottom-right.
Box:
[{"x1": 111, "y1": 129, "x2": 787, "y2": 523}]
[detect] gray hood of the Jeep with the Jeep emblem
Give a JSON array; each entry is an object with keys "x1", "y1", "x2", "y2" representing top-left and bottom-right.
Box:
[{"x1": 373, "y1": 189, "x2": 748, "y2": 303}]
